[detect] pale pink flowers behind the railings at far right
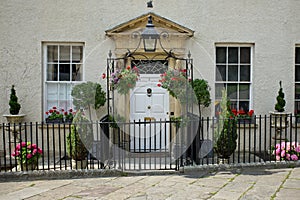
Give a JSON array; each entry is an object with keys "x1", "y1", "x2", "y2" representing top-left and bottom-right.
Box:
[{"x1": 272, "y1": 142, "x2": 300, "y2": 161}]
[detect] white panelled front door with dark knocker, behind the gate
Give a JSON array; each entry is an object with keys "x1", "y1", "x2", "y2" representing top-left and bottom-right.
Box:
[{"x1": 130, "y1": 75, "x2": 169, "y2": 152}]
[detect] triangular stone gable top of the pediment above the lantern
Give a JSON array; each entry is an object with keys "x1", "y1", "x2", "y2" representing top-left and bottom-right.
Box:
[{"x1": 105, "y1": 12, "x2": 194, "y2": 37}]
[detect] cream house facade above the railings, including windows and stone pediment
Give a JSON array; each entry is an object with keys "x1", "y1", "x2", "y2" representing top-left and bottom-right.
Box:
[{"x1": 0, "y1": 0, "x2": 300, "y2": 122}]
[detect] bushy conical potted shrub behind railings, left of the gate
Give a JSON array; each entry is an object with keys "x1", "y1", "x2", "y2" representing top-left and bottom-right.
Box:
[{"x1": 67, "y1": 110, "x2": 93, "y2": 169}]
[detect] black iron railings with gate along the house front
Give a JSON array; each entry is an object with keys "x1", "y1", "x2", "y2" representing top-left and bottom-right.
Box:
[{"x1": 0, "y1": 115, "x2": 300, "y2": 172}]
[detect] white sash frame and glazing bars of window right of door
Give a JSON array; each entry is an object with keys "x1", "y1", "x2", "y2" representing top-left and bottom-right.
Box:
[{"x1": 214, "y1": 43, "x2": 254, "y2": 113}]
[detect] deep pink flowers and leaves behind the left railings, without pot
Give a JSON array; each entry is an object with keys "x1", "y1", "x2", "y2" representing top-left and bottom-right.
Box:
[{"x1": 12, "y1": 142, "x2": 43, "y2": 164}]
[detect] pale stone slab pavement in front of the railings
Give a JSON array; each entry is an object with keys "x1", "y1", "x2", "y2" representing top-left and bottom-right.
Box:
[{"x1": 0, "y1": 167, "x2": 300, "y2": 200}]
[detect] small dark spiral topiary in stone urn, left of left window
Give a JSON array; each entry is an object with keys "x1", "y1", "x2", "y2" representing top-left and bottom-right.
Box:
[{"x1": 3, "y1": 85, "x2": 25, "y2": 124}]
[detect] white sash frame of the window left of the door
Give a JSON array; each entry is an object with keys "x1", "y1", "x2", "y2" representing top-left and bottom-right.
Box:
[{"x1": 42, "y1": 42, "x2": 85, "y2": 119}]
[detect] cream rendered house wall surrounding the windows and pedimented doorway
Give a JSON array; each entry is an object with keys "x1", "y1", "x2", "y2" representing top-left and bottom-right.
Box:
[{"x1": 0, "y1": 0, "x2": 300, "y2": 122}]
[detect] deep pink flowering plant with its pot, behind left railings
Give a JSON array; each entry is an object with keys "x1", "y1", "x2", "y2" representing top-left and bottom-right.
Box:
[{"x1": 12, "y1": 142, "x2": 43, "y2": 171}]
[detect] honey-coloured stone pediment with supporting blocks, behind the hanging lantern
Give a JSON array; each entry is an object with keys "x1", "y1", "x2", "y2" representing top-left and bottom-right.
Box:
[{"x1": 105, "y1": 12, "x2": 194, "y2": 55}]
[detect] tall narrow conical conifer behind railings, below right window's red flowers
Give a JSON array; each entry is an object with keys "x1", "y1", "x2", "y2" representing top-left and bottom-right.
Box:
[{"x1": 214, "y1": 90, "x2": 237, "y2": 163}]
